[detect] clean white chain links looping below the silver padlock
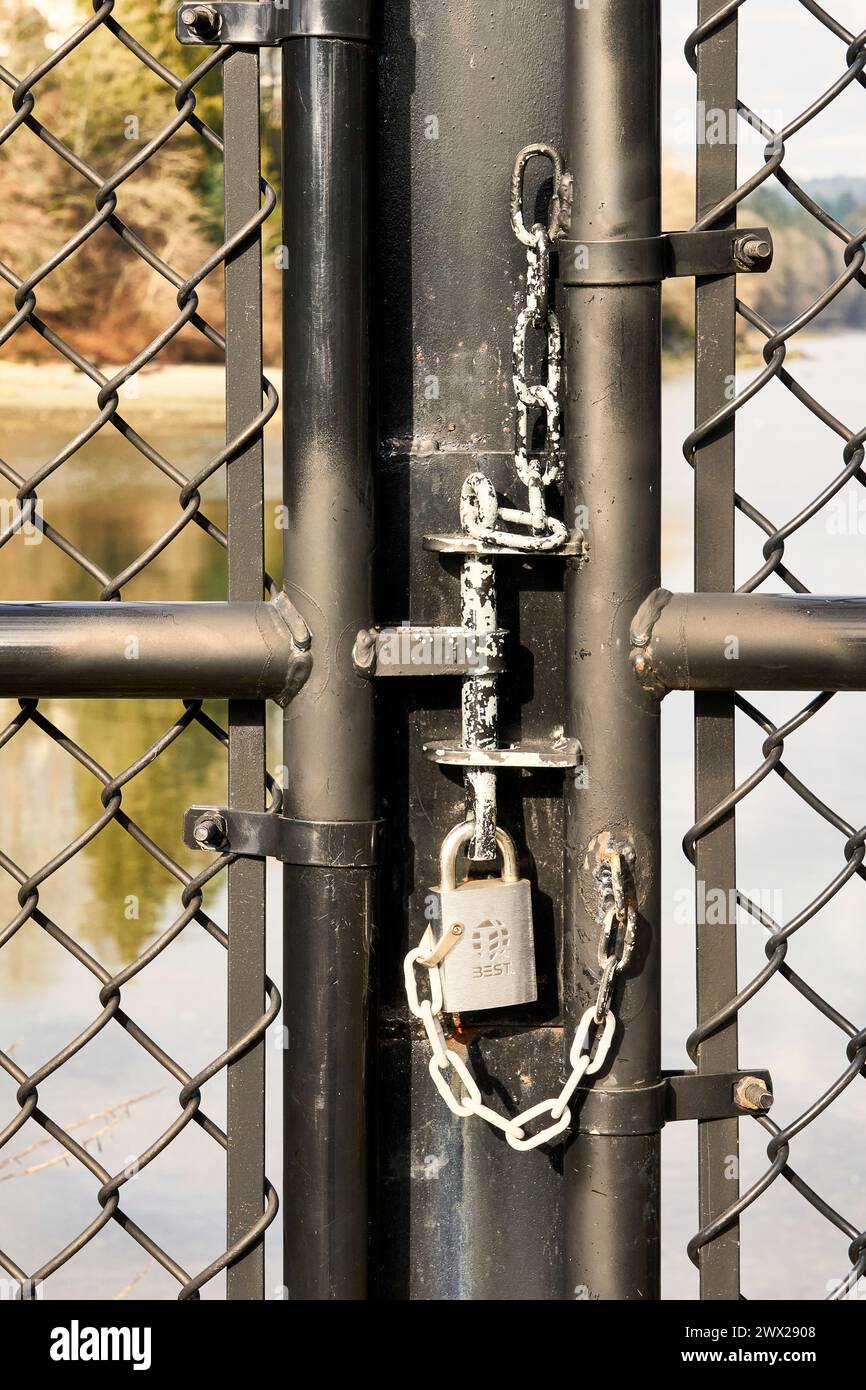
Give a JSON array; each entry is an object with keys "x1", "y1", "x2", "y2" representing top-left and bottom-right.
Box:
[{"x1": 403, "y1": 930, "x2": 616, "y2": 1151}]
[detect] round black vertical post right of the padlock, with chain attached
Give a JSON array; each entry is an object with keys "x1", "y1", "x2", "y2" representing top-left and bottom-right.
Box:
[{"x1": 563, "y1": 0, "x2": 660, "y2": 1300}]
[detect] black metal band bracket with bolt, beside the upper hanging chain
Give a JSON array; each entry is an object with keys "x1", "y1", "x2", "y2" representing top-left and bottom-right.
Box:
[{"x1": 557, "y1": 227, "x2": 773, "y2": 285}]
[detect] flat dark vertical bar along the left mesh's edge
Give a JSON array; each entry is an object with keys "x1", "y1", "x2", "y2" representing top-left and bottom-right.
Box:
[{"x1": 222, "y1": 51, "x2": 265, "y2": 1298}]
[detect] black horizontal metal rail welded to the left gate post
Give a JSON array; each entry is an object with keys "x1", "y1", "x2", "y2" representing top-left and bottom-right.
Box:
[{"x1": 0, "y1": 594, "x2": 311, "y2": 706}]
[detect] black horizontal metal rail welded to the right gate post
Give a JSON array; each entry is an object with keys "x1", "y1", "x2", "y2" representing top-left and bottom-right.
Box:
[{"x1": 631, "y1": 589, "x2": 866, "y2": 695}]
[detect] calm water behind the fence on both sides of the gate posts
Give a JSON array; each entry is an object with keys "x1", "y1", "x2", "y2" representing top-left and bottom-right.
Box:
[{"x1": 0, "y1": 336, "x2": 866, "y2": 1298}]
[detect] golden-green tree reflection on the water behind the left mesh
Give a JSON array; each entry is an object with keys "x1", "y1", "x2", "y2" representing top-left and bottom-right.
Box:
[{"x1": 0, "y1": 370, "x2": 279, "y2": 988}]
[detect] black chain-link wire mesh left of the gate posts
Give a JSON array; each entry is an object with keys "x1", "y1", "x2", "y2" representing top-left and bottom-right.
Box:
[{"x1": 0, "y1": 0, "x2": 281, "y2": 1298}]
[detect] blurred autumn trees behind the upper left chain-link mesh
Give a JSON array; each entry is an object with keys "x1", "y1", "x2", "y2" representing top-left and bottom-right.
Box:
[{"x1": 0, "y1": 0, "x2": 237, "y2": 361}]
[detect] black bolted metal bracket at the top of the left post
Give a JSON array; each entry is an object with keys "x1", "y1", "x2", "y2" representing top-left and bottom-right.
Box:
[{"x1": 177, "y1": 0, "x2": 373, "y2": 49}]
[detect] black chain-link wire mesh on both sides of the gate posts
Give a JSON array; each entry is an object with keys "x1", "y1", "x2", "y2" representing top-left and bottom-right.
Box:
[{"x1": 0, "y1": 0, "x2": 866, "y2": 1298}]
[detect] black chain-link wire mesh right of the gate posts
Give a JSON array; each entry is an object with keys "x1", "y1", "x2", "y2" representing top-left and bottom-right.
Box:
[{"x1": 684, "y1": 0, "x2": 866, "y2": 1300}]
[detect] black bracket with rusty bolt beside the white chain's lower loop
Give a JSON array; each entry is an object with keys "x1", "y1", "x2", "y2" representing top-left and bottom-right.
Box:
[{"x1": 575, "y1": 1069, "x2": 773, "y2": 1134}]
